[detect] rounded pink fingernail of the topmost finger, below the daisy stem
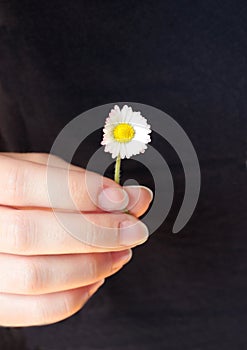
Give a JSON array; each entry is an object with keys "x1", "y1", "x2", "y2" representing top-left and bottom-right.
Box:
[{"x1": 98, "y1": 187, "x2": 129, "y2": 211}]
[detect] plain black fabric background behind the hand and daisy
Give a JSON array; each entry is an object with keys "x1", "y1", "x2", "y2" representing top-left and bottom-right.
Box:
[{"x1": 0, "y1": 0, "x2": 247, "y2": 350}]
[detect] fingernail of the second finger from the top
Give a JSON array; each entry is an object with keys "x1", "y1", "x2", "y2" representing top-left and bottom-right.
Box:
[{"x1": 119, "y1": 221, "x2": 149, "y2": 246}]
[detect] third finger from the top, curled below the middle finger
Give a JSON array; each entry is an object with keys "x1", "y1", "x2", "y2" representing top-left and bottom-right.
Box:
[{"x1": 0, "y1": 250, "x2": 131, "y2": 295}]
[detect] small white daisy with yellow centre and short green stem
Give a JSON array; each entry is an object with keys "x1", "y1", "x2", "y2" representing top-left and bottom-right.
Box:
[{"x1": 101, "y1": 105, "x2": 151, "y2": 182}]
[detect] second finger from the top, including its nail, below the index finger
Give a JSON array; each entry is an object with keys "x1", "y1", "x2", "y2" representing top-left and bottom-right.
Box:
[{"x1": 0, "y1": 208, "x2": 148, "y2": 255}]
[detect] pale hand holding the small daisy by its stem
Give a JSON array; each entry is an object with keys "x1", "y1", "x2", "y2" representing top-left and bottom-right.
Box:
[{"x1": 0, "y1": 153, "x2": 152, "y2": 327}]
